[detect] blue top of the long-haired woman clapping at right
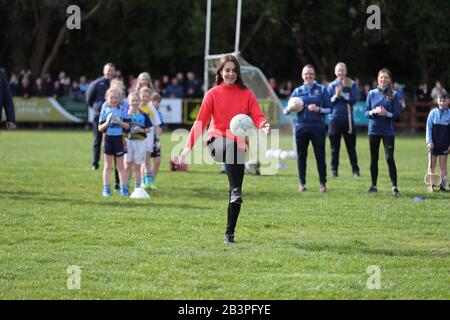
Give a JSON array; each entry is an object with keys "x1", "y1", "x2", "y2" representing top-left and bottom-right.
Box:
[{"x1": 365, "y1": 88, "x2": 400, "y2": 136}]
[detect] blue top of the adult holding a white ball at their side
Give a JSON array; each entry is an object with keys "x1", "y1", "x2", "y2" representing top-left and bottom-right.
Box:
[{"x1": 291, "y1": 81, "x2": 331, "y2": 128}]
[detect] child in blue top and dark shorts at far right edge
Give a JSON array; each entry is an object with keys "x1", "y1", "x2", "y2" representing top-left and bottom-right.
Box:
[{"x1": 426, "y1": 91, "x2": 450, "y2": 192}]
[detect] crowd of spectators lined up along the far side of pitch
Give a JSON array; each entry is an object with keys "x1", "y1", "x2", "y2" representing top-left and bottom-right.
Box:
[{"x1": 9, "y1": 70, "x2": 445, "y2": 108}]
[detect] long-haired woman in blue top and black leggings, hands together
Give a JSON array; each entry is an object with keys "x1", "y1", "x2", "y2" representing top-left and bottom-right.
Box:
[{"x1": 365, "y1": 69, "x2": 400, "y2": 197}]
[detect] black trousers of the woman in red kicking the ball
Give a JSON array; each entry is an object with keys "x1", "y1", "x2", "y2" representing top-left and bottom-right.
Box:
[{"x1": 207, "y1": 137, "x2": 245, "y2": 235}]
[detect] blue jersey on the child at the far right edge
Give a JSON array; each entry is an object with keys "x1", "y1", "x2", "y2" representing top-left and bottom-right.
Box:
[{"x1": 426, "y1": 108, "x2": 450, "y2": 148}]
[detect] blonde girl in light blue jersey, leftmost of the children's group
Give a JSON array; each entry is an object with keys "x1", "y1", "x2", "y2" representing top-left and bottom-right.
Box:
[{"x1": 98, "y1": 88, "x2": 129, "y2": 197}]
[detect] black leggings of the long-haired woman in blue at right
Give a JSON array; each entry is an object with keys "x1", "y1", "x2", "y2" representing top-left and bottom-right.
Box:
[{"x1": 369, "y1": 135, "x2": 397, "y2": 187}]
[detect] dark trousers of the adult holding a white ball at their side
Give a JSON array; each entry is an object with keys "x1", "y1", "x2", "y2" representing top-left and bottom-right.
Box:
[{"x1": 295, "y1": 126, "x2": 327, "y2": 185}]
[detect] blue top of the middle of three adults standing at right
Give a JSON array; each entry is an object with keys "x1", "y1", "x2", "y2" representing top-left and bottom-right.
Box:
[{"x1": 327, "y1": 79, "x2": 358, "y2": 121}]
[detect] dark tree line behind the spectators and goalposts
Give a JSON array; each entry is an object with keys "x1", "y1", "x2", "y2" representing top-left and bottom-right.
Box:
[{"x1": 0, "y1": 0, "x2": 450, "y2": 87}]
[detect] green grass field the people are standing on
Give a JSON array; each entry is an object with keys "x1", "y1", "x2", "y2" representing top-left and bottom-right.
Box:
[{"x1": 0, "y1": 131, "x2": 450, "y2": 299}]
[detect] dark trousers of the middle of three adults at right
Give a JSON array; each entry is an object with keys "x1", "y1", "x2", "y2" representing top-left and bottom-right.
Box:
[{"x1": 328, "y1": 120, "x2": 359, "y2": 172}]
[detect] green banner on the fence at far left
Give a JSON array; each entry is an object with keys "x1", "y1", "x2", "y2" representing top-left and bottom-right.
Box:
[{"x1": 14, "y1": 97, "x2": 83, "y2": 123}]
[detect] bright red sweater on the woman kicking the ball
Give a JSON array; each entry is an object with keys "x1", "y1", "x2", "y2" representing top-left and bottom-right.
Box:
[{"x1": 186, "y1": 83, "x2": 266, "y2": 149}]
